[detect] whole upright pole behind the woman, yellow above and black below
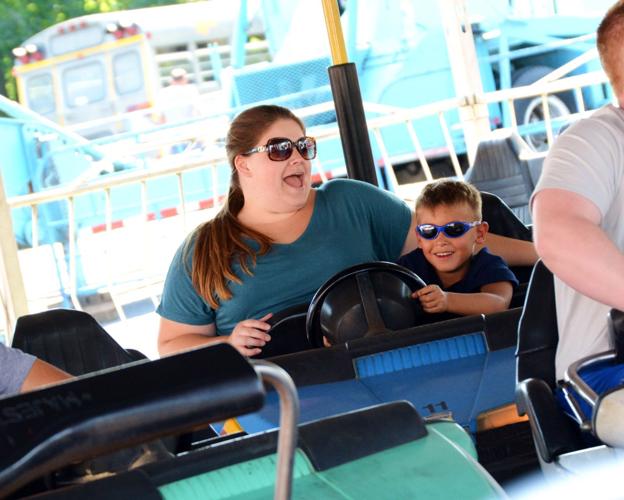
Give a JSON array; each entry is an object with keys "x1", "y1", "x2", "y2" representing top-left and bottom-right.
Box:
[{"x1": 323, "y1": 0, "x2": 377, "y2": 186}]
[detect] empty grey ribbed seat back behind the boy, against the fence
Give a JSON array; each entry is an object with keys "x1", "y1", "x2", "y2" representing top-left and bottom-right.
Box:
[{"x1": 464, "y1": 134, "x2": 542, "y2": 224}]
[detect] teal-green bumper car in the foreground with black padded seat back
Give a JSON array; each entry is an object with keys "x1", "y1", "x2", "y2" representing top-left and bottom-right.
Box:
[{"x1": 0, "y1": 342, "x2": 505, "y2": 499}]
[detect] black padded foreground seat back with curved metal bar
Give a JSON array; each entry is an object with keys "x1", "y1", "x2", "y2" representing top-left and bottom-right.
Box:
[{"x1": 0, "y1": 344, "x2": 274, "y2": 498}]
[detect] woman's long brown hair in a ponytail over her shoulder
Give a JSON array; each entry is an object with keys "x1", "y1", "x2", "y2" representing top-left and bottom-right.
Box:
[{"x1": 190, "y1": 105, "x2": 305, "y2": 309}]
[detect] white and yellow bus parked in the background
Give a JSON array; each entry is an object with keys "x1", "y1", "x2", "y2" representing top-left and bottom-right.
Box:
[{"x1": 13, "y1": 0, "x2": 266, "y2": 138}]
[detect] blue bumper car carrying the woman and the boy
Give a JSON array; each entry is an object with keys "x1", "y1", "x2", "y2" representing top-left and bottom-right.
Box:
[{"x1": 6, "y1": 188, "x2": 535, "y2": 488}]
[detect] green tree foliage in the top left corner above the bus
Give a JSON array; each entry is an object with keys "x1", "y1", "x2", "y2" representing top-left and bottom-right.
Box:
[{"x1": 0, "y1": 0, "x2": 191, "y2": 99}]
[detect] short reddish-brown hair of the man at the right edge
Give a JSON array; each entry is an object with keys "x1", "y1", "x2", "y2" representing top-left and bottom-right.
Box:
[{"x1": 596, "y1": 0, "x2": 624, "y2": 94}]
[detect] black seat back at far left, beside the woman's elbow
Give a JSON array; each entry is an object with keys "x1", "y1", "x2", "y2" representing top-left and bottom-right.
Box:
[{"x1": 12, "y1": 309, "x2": 146, "y2": 376}]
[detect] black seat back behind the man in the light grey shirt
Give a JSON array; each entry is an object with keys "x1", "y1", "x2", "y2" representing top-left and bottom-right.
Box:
[{"x1": 516, "y1": 261, "x2": 586, "y2": 464}]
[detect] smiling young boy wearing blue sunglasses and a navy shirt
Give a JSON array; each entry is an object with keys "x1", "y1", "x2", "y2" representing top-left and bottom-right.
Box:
[{"x1": 399, "y1": 179, "x2": 518, "y2": 315}]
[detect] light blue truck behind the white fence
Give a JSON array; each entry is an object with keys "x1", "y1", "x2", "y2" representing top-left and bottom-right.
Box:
[{"x1": 222, "y1": 0, "x2": 611, "y2": 163}]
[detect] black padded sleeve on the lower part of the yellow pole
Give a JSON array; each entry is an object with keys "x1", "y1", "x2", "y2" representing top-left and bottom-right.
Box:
[{"x1": 328, "y1": 63, "x2": 377, "y2": 186}]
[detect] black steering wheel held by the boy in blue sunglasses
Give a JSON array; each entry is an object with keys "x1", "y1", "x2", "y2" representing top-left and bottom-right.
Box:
[{"x1": 306, "y1": 262, "x2": 425, "y2": 347}]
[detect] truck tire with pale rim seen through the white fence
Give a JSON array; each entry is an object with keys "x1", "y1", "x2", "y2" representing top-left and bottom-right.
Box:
[{"x1": 512, "y1": 66, "x2": 576, "y2": 151}]
